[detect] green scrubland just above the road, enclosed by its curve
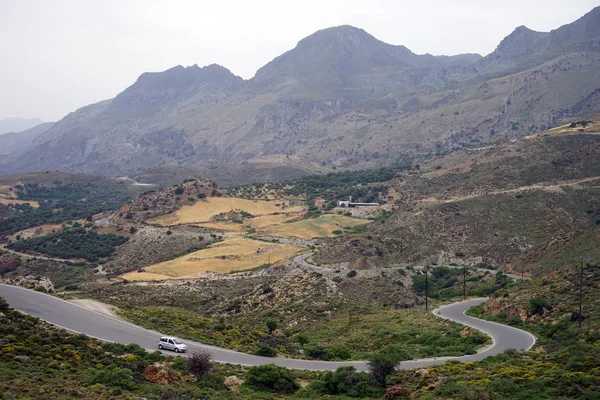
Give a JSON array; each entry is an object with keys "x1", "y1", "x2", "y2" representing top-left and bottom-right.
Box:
[{"x1": 79, "y1": 271, "x2": 488, "y2": 361}]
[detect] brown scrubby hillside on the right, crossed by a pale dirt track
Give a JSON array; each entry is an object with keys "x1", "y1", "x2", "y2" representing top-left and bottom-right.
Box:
[{"x1": 316, "y1": 118, "x2": 600, "y2": 274}]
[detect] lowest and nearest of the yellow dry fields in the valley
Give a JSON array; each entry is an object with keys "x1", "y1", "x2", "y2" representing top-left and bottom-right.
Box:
[{"x1": 144, "y1": 237, "x2": 302, "y2": 278}]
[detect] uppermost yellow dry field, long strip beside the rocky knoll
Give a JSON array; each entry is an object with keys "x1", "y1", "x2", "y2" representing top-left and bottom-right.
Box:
[{"x1": 152, "y1": 197, "x2": 304, "y2": 225}]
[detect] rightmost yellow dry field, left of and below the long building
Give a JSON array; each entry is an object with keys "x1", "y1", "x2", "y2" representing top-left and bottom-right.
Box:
[{"x1": 261, "y1": 214, "x2": 366, "y2": 239}]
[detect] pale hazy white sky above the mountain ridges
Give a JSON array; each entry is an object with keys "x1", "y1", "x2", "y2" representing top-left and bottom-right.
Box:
[{"x1": 0, "y1": 0, "x2": 600, "y2": 121}]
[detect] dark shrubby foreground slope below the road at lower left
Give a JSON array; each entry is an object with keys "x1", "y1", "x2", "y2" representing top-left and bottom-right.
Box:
[{"x1": 0, "y1": 297, "x2": 337, "y2": 400}]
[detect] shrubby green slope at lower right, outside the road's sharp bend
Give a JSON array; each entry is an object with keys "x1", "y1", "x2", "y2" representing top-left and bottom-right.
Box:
[{"x1": 406, "y1": 260, "x2": 600, "y2": 400}]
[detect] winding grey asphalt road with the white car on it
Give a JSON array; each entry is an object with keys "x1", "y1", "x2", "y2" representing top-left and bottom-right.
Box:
[{"x1": 0, "y1": 284, "x2": 535, "y2": 371}]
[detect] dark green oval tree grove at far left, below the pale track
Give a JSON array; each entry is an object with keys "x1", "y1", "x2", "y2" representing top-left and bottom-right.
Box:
[{"x1": 7, "y1": 227, "x2": 128, "y2": 261}]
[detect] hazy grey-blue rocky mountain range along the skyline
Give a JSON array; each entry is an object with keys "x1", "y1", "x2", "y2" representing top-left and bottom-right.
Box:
[{"x1": 0, "y1": 7, "x2": 600, "y2": 183}]
